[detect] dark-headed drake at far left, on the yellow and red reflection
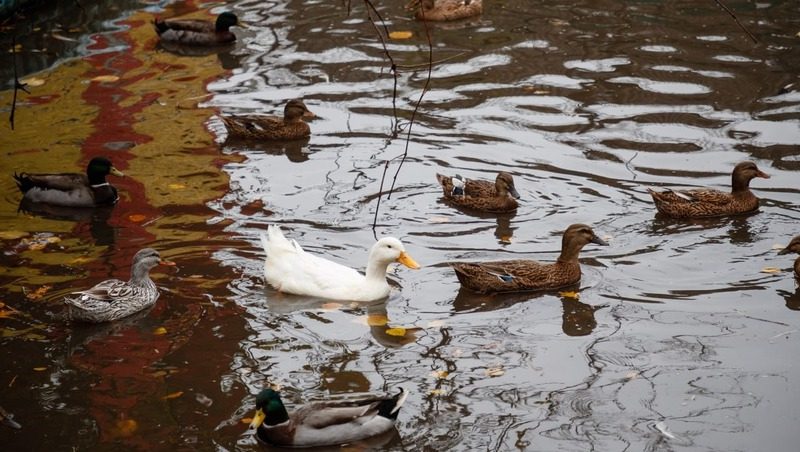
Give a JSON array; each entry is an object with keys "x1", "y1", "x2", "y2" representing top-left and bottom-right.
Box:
[{"x1": 14, "y1": 157, "x2": 124, "y2": 207}]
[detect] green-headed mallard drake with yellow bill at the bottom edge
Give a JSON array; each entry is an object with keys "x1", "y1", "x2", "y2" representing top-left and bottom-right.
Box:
[{"x1": 250, "y1": 388, "x2": 408, "y2": 447}]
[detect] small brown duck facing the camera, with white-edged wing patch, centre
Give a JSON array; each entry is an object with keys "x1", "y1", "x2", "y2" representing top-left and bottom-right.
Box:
[{"x1": 436, "y1": 171, "x2": 519, "y2": 213}]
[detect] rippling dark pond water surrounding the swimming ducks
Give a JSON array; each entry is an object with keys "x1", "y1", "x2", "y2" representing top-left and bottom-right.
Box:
[{"x1": 0, "y1": 0, "x2": 800, "y2": 451}]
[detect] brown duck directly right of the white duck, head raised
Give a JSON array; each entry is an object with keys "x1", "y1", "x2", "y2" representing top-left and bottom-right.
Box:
[{"x1": 451, "y1": 224, "x2": 608, "y2": 293}]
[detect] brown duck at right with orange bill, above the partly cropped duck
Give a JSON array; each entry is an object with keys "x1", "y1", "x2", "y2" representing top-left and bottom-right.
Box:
[{"x1": 647, "y1": 162, "x2": 769, "y2": 218}]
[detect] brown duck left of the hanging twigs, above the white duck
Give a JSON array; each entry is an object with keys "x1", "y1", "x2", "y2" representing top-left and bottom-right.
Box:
[{"x1": 222, "y1": 99, "x2": 315, "y2": 140}]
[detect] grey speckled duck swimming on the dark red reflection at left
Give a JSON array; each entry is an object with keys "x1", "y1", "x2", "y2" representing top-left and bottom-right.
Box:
[{"x1": 64, "y1": 248, "x2": 175, "y2": 323}]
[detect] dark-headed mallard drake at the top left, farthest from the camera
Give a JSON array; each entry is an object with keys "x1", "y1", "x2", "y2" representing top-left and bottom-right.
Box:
[{"x1": 153, "y1": 12, "x2": 239, "y2": 46}]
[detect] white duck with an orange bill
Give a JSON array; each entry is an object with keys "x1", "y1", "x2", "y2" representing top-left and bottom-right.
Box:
[{"x1": 261, "y1": 225, "x2": 419, "y2": 301}]
